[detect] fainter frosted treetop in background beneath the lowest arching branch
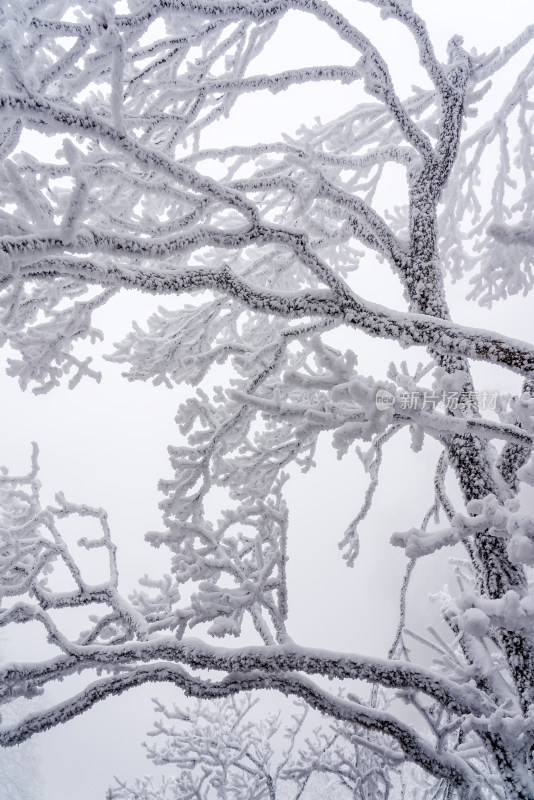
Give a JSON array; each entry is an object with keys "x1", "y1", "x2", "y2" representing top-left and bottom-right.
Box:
[{"x1": 109, "y1": 692, "x2": 394, "y2": 800}]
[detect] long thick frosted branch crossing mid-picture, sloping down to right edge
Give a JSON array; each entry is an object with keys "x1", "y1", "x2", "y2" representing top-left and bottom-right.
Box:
[{"x1": 9, "y1": 255, "x2": 534, "y2": 376}]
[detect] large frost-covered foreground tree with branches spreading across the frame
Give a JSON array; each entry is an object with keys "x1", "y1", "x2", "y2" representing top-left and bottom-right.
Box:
[{"x1": 0, "y1": 0, "x2": 534, "y2": 800}]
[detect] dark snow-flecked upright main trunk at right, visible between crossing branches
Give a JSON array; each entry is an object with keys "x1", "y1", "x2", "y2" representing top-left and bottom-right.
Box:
[{"x1": 404, "y1": 153, "x2": 534, "y2": 800}]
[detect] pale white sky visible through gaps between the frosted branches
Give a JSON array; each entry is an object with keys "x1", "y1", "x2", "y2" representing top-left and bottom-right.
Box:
[{"x1": 0, "y1": 0, "x2": 532, "y2": 800}]
